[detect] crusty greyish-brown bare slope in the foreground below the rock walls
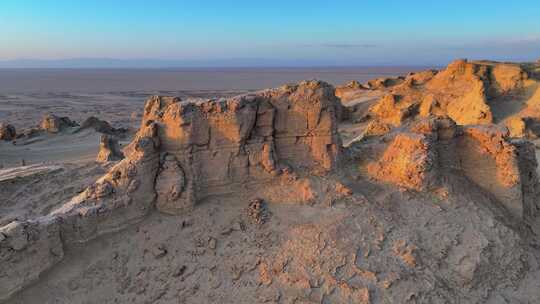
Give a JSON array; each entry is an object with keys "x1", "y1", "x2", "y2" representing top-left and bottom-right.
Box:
[{"x1": 8, "y1": 171, "x2": 538, "y2": 303}]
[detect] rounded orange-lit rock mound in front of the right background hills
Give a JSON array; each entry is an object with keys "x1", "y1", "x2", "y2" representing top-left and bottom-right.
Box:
[{"x1": 367, "y1": 117, "x2": 539, "y2": 219}]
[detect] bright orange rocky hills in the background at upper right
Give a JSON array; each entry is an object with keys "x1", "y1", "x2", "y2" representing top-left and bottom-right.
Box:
[{"x1": 342, "y1": 59, "x2": 540, "y2": 136}]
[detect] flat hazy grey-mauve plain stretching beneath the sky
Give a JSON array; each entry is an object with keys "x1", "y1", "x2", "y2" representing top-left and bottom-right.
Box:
[{"x1": 0, "y1": 66, "x2": 434, "y2": 95}]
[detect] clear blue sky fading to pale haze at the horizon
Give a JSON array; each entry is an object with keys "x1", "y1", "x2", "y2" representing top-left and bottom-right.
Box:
[{"x1": 0, "y1": 0, "x2": 540, "y2": 67}]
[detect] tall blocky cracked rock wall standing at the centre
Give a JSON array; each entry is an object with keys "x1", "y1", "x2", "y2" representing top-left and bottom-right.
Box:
[{"x1": 142, "y1": 81, "x2": 340, "y2": 213}]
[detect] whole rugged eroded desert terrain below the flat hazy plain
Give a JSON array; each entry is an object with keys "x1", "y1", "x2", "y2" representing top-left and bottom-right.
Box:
[{"x1": 0, "y1": 60, "x2": 540, "y2": 304}]
